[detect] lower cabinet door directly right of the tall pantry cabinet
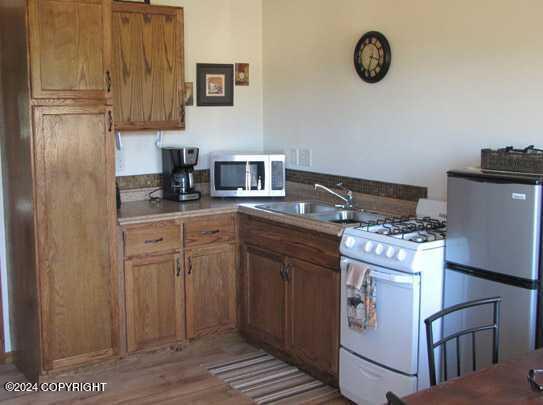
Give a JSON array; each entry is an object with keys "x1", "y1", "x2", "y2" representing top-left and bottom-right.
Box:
[{"x1": 124, "y1": 254, "x2": 185, "y2": 352}]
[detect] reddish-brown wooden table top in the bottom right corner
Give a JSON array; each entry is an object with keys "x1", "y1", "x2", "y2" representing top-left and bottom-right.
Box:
[{"x1": 402, "y1": 349, "x2": 543, "y2": 405}]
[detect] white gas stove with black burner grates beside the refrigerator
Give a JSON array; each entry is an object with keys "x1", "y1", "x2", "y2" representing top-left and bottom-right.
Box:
[{"x1": 339, "y1": 200, "x2": 447, "y2": 404}]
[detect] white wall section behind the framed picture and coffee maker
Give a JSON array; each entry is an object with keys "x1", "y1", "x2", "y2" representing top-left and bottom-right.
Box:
[{"x1": 117, "y1": 0, "x2": 263, "y2": 176}]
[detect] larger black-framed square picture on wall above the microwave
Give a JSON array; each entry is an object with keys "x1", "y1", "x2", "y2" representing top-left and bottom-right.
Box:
[{"x1": 196, "y1": 63, "x2": 234, "y2": 107}]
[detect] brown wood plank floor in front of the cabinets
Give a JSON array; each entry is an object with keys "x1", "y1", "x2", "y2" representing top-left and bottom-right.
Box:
[{"x1": 0, "y1": 334, "x2": 348, "y2": 405}]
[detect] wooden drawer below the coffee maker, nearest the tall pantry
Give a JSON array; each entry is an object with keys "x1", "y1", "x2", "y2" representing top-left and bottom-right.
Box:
[{"x1": 124, "y1": 222, "x2": 181, "y2": 257}]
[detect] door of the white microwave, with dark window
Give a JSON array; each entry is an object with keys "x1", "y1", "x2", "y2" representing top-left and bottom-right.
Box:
[{"x1": 210, "y1": 155, "x2": 268, "y2": 197}]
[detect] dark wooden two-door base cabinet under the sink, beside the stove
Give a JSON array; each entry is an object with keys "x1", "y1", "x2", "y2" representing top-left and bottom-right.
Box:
[{"x1": 240, "y1": 214, "x2": 340, "y2": 384}]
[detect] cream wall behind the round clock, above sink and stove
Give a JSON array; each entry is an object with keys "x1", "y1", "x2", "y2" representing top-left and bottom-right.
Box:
[{"x1": 263, "y1": 0, "x2": 543, "y2": 198}]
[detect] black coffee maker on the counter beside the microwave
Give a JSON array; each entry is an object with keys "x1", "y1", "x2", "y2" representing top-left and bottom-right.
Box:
[{"x1": 162, "y1": 146, "x2": 200, "y2": 202}]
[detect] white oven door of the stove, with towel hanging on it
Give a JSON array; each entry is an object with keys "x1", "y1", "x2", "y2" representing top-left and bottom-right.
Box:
[{"x1": 341, "y1": 257, "x2": 420, "y2": 375}]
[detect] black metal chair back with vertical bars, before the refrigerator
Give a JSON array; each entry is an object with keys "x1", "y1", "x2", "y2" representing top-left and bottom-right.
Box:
[{"x1": 424, "y1": 297, "x2": 501, "y2": 385}]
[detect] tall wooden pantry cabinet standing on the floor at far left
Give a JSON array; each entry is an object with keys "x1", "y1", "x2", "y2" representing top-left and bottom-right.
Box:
[{"x1": 0, "y1": 0, "x2": 119, "y2": 381}]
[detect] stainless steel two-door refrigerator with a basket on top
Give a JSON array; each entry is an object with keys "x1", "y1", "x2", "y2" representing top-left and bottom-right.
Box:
[{"x1": 443, "y1": 169, "x2": 543, "y2": 375}]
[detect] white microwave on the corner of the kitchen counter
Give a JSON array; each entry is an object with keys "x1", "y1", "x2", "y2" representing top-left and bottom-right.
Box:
[{"x1": 209, "y1": 152, "x2": 286, "y2": 197}]
